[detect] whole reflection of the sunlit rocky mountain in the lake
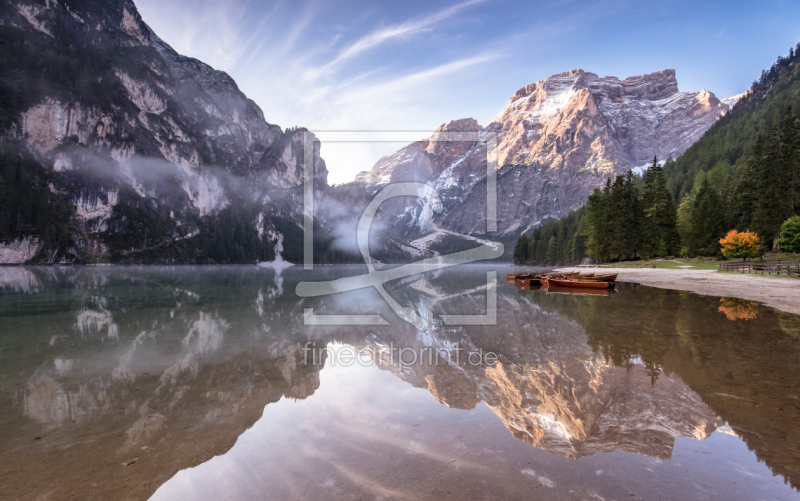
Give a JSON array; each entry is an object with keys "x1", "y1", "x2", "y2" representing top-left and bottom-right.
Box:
[{"x1": 364, "y1": 279, "x2": 725, "y2": 459}]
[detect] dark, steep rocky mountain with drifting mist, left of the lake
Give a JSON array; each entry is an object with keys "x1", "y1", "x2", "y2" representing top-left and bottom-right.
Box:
[{"x1": 0, "y1": 0, "x2": 327, "y2": 262}]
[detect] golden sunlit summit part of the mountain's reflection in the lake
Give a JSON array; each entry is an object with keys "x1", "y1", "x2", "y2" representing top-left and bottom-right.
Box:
[{"x1": 484, "y1": 358, "x2": 724, "y2": 459}]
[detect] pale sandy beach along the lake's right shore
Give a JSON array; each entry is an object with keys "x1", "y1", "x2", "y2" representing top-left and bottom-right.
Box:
[{"x1": 559, "y1": 268, "x2": 800, "y2": 315}]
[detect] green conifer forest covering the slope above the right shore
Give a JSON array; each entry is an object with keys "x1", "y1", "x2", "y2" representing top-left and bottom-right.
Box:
[{"x1": 514, "y1": 44, "x2": 800, "y2": 265}]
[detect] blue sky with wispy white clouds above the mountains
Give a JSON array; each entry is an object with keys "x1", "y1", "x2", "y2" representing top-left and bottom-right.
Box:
[{"x1": 134, "y1": 0, "x2": 800, "y2": 183}]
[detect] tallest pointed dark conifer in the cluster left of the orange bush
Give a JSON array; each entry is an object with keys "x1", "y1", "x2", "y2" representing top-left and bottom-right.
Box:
[{"x1": 642, "y1": 157, "x2": 680, "y2": 258}]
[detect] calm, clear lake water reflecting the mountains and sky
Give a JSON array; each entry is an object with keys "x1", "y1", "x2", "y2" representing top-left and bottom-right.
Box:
[{"x1": 0, "y1": 266, "x2": 800, "y2": 500}]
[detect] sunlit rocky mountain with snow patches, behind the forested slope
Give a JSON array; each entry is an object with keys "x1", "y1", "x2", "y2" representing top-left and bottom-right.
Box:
[{"x1": 356, "y1": 69, "x2": 736, "y2": 247}]
